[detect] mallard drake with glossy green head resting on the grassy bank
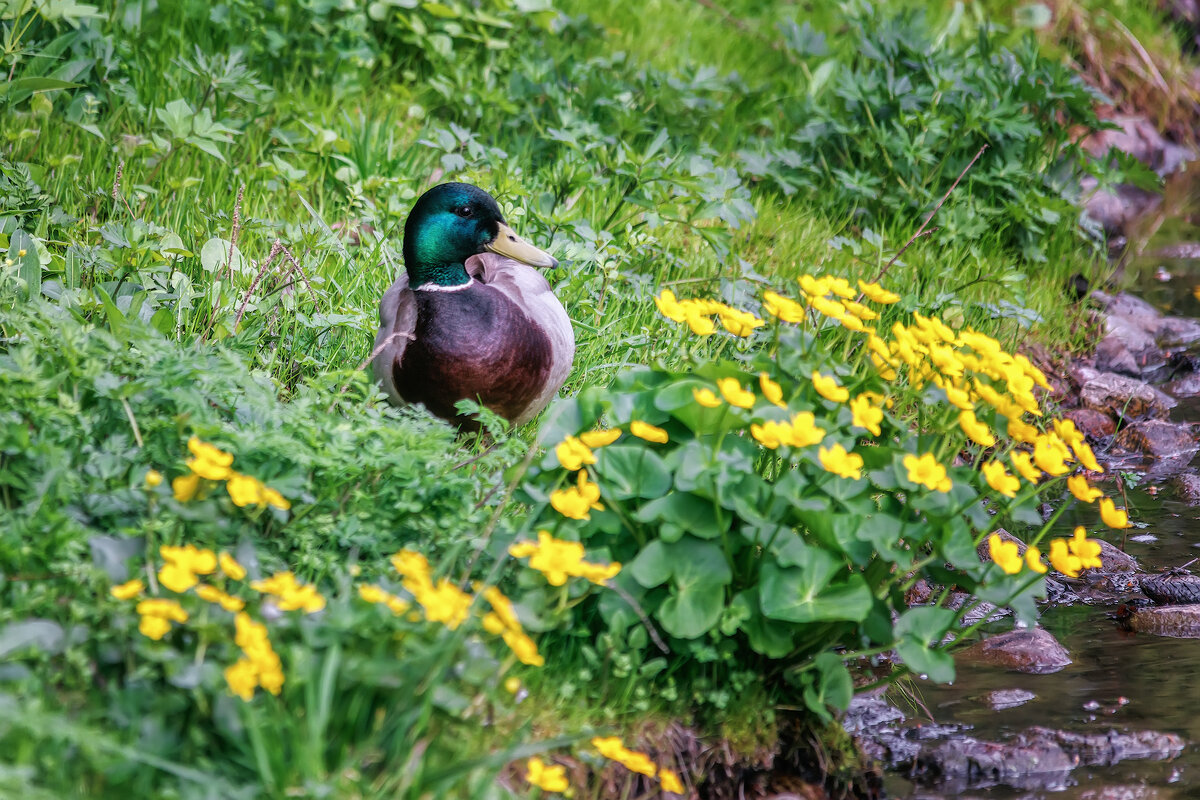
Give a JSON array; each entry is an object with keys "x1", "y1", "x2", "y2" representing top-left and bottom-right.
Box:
[{"x1": 374, "y1": 184, "x2": 575, "y2": 429}]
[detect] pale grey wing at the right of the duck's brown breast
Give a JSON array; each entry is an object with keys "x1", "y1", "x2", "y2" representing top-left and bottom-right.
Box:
[{"x1": 463, "y1": 253, "x2": 575, "y2": 425}]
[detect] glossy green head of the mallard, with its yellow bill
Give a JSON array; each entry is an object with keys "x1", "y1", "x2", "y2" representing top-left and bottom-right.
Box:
[{"x1": 404, "y1": 184, "x2": 558, "y2": 288}]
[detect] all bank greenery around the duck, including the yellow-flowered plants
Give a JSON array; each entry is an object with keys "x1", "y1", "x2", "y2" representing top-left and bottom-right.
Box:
[{"x1": 0, "y1": 0, "x2": 1180, "y2": 798}]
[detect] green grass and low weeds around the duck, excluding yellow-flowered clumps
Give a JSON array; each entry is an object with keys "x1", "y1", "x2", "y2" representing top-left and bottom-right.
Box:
[{"x1": 0, "y1": 0, "x2": 1190, "y2": 796}]
